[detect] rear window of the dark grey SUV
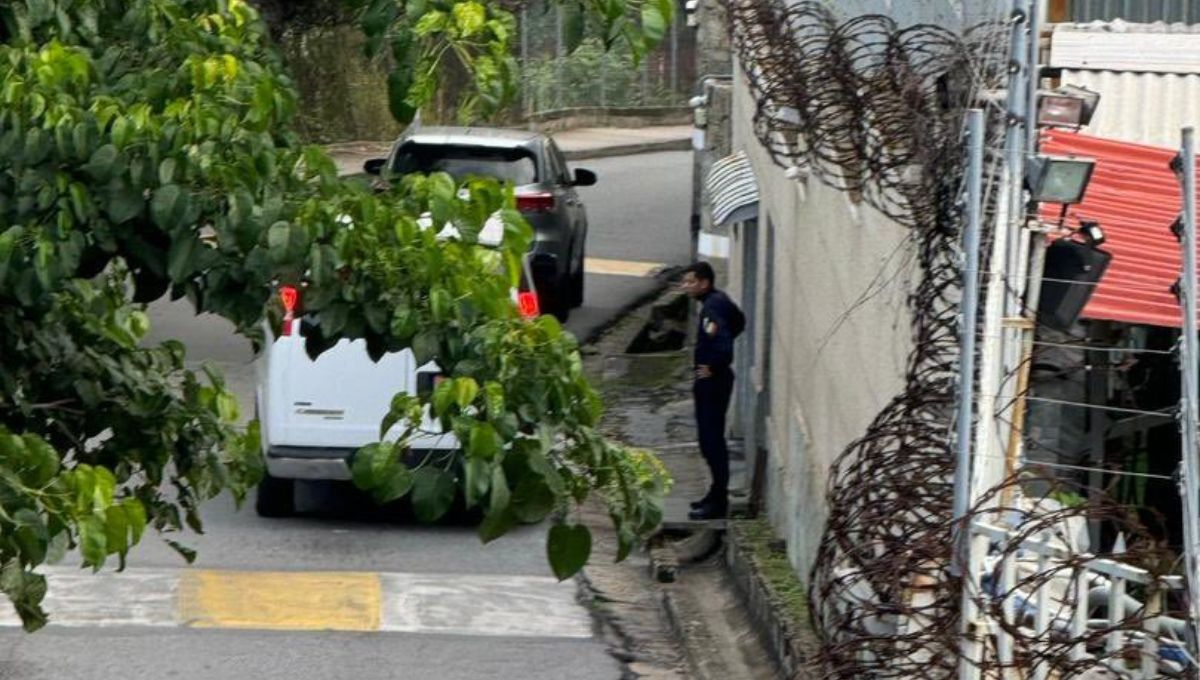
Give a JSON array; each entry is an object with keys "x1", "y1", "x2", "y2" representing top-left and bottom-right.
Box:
[{"x1": 391, "y1": 144, "x2": 538, "y2": 186}]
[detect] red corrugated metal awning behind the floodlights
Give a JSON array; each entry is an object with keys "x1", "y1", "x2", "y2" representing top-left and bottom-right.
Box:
[{"x1": 1040, "y1": 130, "x2": 1182, "y2": 327}]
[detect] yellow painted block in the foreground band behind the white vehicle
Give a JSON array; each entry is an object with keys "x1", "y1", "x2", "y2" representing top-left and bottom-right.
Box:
[{"x1": 179, "y1": 571, "x2": 382, "y2": 631}]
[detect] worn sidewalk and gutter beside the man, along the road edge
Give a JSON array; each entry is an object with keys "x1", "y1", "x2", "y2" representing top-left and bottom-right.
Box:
[{"x1": 582, "y1": 294, "x2": 808, "y2": 680}]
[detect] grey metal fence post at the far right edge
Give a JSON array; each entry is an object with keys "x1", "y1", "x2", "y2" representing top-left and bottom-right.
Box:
[{"x1": 1180, "y1": 127, "x2": 1200, "y2": 639}]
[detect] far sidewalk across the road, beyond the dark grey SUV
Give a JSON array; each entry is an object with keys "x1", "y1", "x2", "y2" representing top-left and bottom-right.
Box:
[{"x1": 325, "y1": 125, "x2": 692, "y2": 175}]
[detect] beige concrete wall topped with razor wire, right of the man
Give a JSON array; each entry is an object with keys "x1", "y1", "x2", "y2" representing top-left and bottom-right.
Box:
[{"x1": 730, "y1": 65, "x2": 912, "y2": 577}]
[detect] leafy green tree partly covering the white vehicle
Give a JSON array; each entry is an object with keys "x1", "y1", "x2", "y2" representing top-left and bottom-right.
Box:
[{"x1": 0, "y1": 0, "x2": 671, "y2": 630}]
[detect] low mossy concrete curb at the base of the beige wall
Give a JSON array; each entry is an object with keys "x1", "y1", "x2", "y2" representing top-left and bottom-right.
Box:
[{"x1": 725, "y1": 523, "x2": 820, "y2": 680}]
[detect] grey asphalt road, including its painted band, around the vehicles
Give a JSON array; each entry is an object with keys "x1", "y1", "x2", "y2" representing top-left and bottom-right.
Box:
[{"x1": 0, "y1": 152, "x2": 691, "y2": 680}]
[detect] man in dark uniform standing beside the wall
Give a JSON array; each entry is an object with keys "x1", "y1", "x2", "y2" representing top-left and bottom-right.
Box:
[{"x1": 680, "y1": 261, "x2": 745, "y2": 519}]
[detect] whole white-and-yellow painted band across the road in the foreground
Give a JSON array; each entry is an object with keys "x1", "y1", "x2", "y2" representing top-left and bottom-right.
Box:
[{"x1": 0, "y1": 567, "x2": 593, "y2": 638}]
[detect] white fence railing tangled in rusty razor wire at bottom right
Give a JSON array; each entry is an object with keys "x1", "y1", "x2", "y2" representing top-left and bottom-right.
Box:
[{"x1": 959, "y1": 522, "x2": 1195, "y2": 680}]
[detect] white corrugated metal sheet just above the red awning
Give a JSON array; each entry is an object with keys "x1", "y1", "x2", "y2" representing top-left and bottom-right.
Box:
[{"x1": 1062, "y1": 71, "x2": 1200, "y2": 149}]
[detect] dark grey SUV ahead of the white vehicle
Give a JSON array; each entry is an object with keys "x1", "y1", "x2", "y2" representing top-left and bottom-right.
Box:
[{"x1": 364, "y1": 127, "x2": 596, "y2": 320}]
